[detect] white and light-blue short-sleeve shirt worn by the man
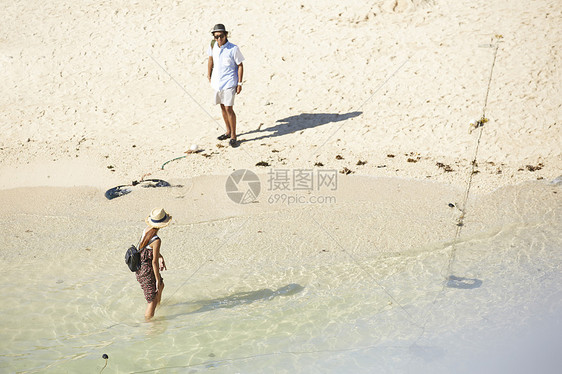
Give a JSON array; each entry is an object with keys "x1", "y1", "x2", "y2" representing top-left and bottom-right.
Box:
[{"x1": 207, "y1": 42, "x2": 244, "y2": 91}]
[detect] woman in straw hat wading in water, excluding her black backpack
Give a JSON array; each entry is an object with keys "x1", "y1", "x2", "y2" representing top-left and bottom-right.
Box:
[{"x1": 136, "y1": 208, "x2": 172, "y2": 320}]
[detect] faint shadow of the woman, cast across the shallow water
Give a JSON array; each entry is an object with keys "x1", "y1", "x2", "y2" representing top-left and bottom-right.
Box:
[{"x1": 165, "y1": 283, "x2": 304, "y2": 319}]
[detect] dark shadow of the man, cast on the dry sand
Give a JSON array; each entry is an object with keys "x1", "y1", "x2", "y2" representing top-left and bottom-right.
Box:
[{"x1": 238, "y1": 112, "x2": 363, "y2": 142}]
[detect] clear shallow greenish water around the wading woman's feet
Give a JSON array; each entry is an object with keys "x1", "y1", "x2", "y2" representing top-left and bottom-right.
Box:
[{"x1": 0, "y1": 180, "x2": 562, "y2": 373}]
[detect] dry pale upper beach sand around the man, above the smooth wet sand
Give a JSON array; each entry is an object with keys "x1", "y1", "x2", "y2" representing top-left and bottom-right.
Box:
[{"x1": 0, "y1": 0, "x2": 562, "y2": 191}]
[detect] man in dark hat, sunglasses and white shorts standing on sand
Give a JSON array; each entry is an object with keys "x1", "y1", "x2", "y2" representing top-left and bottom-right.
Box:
[{"x1": 207, "y1": 23, "x2": 244, "y2": 147}]
